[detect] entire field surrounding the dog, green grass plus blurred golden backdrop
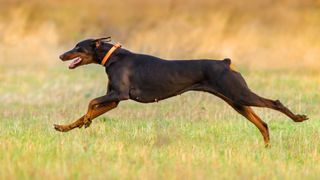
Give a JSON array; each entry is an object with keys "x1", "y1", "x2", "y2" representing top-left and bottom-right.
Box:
[{"x1": 0, "y1": 0, "x2": 320, "y2": 180}]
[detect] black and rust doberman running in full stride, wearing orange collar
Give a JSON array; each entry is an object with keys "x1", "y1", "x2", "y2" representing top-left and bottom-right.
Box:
[{"x1": 54, "y1": 37, "x2": 308, "y2": 146}]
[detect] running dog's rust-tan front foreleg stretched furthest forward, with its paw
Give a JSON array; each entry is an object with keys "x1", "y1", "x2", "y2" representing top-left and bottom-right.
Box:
[{"x1": 54, "y1": 102, "x2": 119, "y2": 132}]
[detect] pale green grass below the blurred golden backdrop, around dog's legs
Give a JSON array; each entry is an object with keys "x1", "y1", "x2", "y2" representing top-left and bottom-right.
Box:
[{"x1": 0, "y1": 64, "x2": 320, "y2": 179}]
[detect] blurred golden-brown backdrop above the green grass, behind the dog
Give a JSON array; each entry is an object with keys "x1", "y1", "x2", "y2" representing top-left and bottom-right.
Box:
[{"x1": 0, "y1": 0, "x2": 320, "y2": 69}]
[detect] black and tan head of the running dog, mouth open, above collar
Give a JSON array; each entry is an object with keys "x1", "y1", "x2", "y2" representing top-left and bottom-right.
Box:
[{"x1": 60, "y1": 37, "x2": 111, "y2": 69}]
